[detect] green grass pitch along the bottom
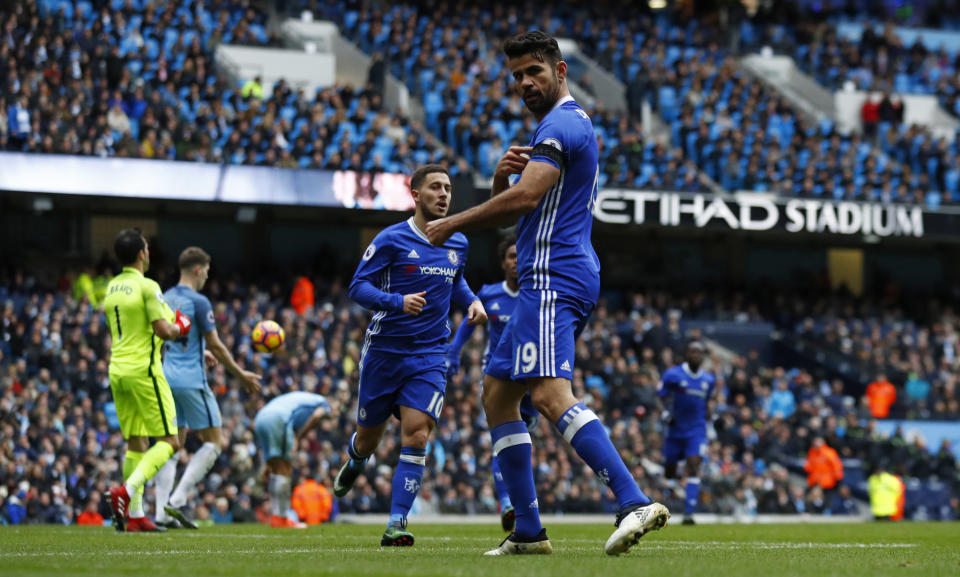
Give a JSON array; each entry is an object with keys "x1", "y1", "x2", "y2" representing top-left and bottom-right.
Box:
[{"x1": 0, "y1": 521, "x2": 960, "y2": 577}]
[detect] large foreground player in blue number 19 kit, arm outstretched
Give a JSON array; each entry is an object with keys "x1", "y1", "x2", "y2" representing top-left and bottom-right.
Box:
[{"x1": 427, "y1": 31, "x2": 670, "y2": 555}]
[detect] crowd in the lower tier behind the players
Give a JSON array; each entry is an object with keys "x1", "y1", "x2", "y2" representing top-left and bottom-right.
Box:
[{"x1": 0, "y1": 269, "x2": 960, "y2": 523}]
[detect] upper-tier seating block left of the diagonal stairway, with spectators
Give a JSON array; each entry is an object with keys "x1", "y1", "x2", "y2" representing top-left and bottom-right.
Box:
[{"x1": 0, "y1": 1, "x2": 461, "y2": 172}]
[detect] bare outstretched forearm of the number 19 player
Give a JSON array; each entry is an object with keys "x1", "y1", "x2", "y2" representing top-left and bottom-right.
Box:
[{"x1": 426, "y1": 162, "x2": 560, "y2": 246}]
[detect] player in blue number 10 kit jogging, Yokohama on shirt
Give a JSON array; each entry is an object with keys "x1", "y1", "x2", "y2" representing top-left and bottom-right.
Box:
[{"x1": 333, "y1": 164, "x2": 487, "y2": 547}]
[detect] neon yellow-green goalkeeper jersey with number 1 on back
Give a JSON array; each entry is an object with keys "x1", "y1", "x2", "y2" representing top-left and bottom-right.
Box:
[{"x1": 103, "y1": 267, "x2": 174, "y2": 376}]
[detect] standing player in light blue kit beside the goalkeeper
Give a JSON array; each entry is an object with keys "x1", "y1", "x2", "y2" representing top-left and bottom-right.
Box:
[{"x1": 156, "y1": 246, "x2": 260, "y2": 529}]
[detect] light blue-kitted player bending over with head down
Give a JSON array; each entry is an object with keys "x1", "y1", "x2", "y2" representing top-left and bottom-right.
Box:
[{"x1": 253, "y1": 391, "x2": 335, "y2": 529}]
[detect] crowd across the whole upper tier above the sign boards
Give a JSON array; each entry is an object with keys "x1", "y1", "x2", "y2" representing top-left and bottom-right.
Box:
[{"x1": 0, "y1": 0, "x2": 960, "y2": 206}]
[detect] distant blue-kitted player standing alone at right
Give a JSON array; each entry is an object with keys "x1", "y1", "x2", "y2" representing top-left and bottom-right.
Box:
[{"x1": 658, "y1": 341, "x2": 716, "y2": 525}]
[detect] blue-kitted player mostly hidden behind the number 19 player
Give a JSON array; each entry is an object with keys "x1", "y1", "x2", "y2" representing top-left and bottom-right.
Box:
[{"x1": 447, "y1": 234, "x2": 538, "y2": 531}]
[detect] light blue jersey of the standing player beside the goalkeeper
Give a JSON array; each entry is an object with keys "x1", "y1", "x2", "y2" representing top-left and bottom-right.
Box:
[{"x1": 163, "y1": 285, "x2": 216, "y2": 389}]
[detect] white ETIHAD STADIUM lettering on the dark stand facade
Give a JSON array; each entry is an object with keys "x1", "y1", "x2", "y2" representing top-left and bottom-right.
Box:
[{"x1": 593, "y1": 189, "x2": 928, "y2": 238}]
